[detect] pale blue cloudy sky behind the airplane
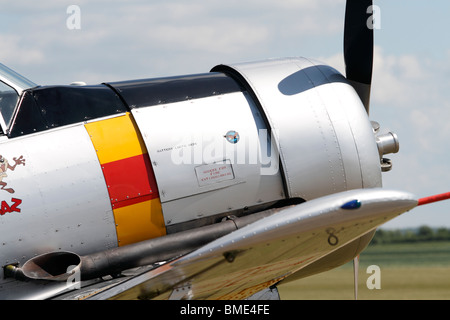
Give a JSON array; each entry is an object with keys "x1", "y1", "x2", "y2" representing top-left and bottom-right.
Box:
[{"x1": 0, "y1": 0, "x2": 450, "y2": 228}]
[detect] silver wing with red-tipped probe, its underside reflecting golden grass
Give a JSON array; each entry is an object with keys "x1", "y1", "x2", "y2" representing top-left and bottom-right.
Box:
[{"x1": 86, "y1": 189, "x2": 417, "y2": 299}]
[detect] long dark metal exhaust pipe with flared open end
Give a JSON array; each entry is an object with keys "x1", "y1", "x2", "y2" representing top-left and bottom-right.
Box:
[{"x1": 4, "y1": 207, "x2": 292, "y2": 281}]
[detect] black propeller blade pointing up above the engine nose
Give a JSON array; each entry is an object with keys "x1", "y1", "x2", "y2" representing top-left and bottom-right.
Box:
[{"x1": 344, "y1": 0, "x2": 373, "y2": 113}]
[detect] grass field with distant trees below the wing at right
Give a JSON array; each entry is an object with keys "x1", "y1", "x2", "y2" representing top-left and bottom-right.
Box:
[{"x1": 278, "y1": 242, "x2": 450, "y2": 300}]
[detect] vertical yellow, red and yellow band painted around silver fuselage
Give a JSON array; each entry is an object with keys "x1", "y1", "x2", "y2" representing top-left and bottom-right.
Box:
[{"x1": 85, "y1": 113, "x2": 166, "y2": 246}]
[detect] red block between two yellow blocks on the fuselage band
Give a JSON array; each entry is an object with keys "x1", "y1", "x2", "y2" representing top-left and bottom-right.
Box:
[{"x1": 102, "y1": 154, "x2": 159, "y2": 207}]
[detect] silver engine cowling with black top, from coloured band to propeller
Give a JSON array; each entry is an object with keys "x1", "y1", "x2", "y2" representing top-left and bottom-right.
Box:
[{"x1": 104, "y1": 58, "x2": 381, "y2": 233}]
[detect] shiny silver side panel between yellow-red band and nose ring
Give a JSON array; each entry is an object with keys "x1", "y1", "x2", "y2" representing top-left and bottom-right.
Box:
[{"x1": 132, "y1": 92, "x2": 284, "y2": 226}]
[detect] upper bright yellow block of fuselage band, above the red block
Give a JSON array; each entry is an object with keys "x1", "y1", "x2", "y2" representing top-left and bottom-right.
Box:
[{"x1": 85, "y1": 113, "x2": 147, "y2": 164}]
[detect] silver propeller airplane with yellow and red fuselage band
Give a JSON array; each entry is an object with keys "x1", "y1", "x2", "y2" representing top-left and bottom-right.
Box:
[{"x1": 0, "y1": 0, "x2": 450, "y2": 300}]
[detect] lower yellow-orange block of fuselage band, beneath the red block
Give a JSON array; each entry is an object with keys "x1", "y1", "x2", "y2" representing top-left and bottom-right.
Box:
[{"x1": 114, "y1": 198, "x2": 166, "y2": 246}]
